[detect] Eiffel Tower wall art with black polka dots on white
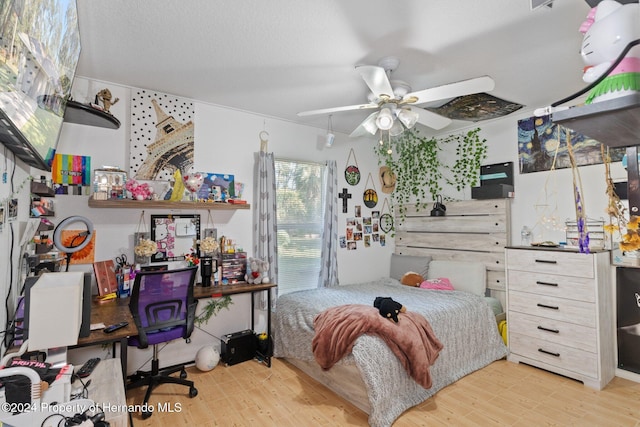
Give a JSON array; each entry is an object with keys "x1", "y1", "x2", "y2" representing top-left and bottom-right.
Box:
[{"x1": 129, "y1": 89, "x2": 194, "y2": 181}]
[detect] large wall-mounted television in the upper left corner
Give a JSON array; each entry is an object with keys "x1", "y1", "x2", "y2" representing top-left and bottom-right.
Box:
[{"x1": 0, "y1": 0, "x2": 80, "y2": 171}]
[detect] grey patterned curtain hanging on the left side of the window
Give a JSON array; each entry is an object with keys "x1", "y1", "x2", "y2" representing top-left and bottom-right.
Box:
[{"x1": 253, "y1": 145, "x2": 278, "y2": 310}]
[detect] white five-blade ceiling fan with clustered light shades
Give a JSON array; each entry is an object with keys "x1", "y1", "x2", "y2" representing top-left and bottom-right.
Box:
[{"x1": 298, "y1": 57, "x2": 495, "y2": 136}]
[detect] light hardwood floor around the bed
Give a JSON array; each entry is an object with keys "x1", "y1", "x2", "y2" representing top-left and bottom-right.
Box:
[{"x1": 127, "y1": 359, "x2": 640, "y2": 427}]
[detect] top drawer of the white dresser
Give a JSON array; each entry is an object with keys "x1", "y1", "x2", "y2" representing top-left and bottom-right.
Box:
[{"x1": 507, "y1": 249, "x2": 594, "y2": 278}]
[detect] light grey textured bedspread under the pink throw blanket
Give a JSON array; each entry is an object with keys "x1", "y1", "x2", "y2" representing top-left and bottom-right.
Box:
[{"x1": 274, "y1": 279, "x2": 507, "y2": 427}]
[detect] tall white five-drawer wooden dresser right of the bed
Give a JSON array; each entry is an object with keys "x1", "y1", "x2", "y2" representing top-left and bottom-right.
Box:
[{"x1": 506, "y1": 247, "x2": 615, "y2": 390}]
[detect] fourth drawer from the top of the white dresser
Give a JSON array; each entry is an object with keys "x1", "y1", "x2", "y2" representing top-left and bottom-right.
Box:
[{"x1": 507, "y1": 311, "x2": 598, "y2": 353}]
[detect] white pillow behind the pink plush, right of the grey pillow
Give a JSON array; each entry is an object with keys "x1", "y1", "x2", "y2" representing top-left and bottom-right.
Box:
[{"x1": 426, "y1": 260, "x2": 487, "y2": 296}]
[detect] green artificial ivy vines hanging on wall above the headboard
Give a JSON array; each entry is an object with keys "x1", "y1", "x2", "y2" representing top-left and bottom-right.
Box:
[{"x1": 374, "y1": 128, "x2": 487, "y2": 226}]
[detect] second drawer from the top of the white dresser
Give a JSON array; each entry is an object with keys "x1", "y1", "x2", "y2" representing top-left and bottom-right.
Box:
[{"x1": 508, "y1": 270, "x2": 596, "y2": 303}]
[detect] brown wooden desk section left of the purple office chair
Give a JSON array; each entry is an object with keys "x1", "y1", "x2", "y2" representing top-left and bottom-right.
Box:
[{"x1": 70, "y1": 298, "x2": 138, "y2": 379}]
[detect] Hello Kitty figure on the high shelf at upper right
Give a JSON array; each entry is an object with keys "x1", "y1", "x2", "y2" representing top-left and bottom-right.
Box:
[{"x1": 580, "y1": 0, "x2": 640, "y2": 104}]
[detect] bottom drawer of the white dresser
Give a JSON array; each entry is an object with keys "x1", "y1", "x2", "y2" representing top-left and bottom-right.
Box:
[{"x1": 509, "y1": 333, "x2": 598, "y2": 378}]
